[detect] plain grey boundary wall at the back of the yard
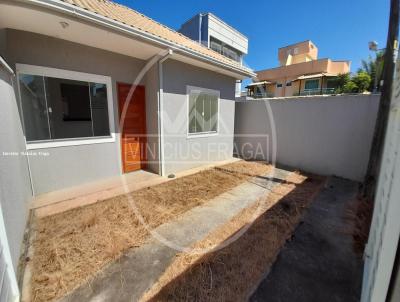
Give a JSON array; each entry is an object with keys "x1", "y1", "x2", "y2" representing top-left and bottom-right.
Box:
[{"x1": 235, "y1": 95, "x2": 379, "y2": 181}]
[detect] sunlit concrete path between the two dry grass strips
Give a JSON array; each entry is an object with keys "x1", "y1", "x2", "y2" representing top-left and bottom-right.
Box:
[{"x1": 63, "y1": 169, "x2": 289, "y2": 302}]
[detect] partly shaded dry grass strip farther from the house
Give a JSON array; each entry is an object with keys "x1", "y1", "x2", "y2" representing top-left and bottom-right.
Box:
[{"x1": 142, "y1": 173, "x2": 324, "y2": 301}]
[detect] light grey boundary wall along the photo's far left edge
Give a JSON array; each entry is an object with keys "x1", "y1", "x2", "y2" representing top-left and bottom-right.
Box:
[{"x1": 0, "y1": 58, "x2": 25, "y2": 302}]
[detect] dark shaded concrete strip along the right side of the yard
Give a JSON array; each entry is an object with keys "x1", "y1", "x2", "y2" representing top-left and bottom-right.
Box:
[{"x1": 250, "y1": 177, "x2": 362, "y2": 302}]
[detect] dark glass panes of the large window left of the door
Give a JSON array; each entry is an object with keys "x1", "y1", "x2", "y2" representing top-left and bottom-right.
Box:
[{"x1": 19, "y1": 74, "x2": 110, "y2": 142}]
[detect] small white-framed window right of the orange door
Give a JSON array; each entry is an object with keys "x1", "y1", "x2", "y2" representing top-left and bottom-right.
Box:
[{"x1": 188, "y1": 89, "x2": 218, "y2": 134}]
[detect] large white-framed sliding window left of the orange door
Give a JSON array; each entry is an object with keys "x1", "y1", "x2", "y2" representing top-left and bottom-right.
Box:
[{"x1": 17, "y1": 65, "x2": 113, "y2": 147}]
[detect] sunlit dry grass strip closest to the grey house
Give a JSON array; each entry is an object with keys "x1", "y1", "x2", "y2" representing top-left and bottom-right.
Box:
[{"x1": 30, "y1": 161, "x2": 271, "y2": 301}]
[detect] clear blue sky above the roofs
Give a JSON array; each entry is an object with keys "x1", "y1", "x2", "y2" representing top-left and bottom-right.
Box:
[{"x1": 116, "y1": 0, "x2": 389, "y2": 72}]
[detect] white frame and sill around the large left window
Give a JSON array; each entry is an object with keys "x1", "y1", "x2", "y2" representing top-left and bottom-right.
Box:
[{"x1": 16, "y1": 64, "x2": 116, "y2": 150}]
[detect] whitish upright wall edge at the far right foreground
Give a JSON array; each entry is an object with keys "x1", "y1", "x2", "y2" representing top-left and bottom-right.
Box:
[{"x1": 361, "y1": 60, "x2": 400, "y2": 302}]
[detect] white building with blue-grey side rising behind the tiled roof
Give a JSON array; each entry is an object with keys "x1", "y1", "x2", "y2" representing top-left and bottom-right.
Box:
[{"x1": 178, "y1": 13, "x2": 249, "y2": 96}]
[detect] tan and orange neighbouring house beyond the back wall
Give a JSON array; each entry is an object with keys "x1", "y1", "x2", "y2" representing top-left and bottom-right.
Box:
[{"x1": 246, "y1": 40, "x2": 350, "y2": 97}]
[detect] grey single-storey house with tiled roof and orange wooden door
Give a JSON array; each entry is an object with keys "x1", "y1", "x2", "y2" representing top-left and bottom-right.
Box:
[{"x1": 0, "y1": 0, "x2": 255, "y2": 294}]
